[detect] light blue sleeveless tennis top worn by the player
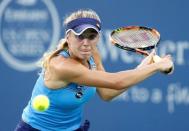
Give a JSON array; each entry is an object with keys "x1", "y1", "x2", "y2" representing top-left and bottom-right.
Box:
[{"x1": 22, "y1": 51, "x2": 96, "y2": 131}]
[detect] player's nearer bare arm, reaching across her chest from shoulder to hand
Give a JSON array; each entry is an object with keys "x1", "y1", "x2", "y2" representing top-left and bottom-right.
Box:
[{"x1": 50, "y1": 48, "x2": 171, "y2": 95}]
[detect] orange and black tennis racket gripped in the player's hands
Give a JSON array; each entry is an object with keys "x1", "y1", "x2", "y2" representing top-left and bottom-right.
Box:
[{"x1": 110, "y1": 26, "x2": 174, "y2": 74}]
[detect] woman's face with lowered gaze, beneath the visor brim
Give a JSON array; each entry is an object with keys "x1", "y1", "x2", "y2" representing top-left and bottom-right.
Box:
[{"x1": 67, "y1": 29, "x2": 99, "y2": 60}]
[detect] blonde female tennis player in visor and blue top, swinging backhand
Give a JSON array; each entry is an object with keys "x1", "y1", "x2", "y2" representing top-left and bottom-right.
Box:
[{"x1": 15, "y1": 9, "x2": 172, "y2": 131}]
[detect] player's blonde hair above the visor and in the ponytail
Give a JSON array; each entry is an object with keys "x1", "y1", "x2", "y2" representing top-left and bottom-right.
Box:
[{"x1": 39, "y1": 9, "x2": 100, "y2": 69}]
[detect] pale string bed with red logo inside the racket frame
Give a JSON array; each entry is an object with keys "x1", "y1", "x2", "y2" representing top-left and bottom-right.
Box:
[{"x1": 113, "y1": 30, "x2": 159, "y2": 48}]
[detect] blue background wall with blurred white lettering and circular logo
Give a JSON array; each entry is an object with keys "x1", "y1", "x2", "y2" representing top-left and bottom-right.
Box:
[{"x1": 0, "y1": 0, "x2": 189, "y2": 131}]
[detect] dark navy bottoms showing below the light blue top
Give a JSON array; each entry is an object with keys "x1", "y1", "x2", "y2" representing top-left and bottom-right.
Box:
[{"x1": 14, "y1": 120, "x2": 90, "y2": 131}]
